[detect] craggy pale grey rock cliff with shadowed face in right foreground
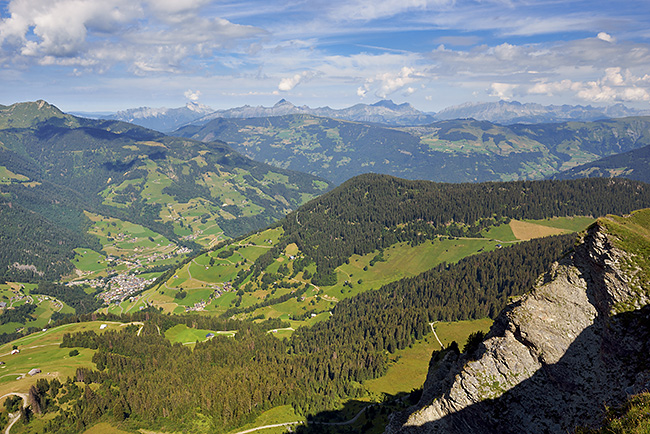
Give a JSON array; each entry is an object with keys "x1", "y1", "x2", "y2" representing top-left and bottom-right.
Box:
[{"x1": 386, "y1": 210, "x2": 650, "y2": 434}]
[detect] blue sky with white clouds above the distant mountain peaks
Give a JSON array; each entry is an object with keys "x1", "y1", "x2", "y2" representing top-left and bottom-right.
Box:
[{"x1": 0, "y1": 0, "x2": 650, "y2": 112}]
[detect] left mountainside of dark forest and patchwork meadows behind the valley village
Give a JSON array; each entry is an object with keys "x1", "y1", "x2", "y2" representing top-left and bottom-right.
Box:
[{"x1": 0, "y1": 101, "x2": 329, "y2": 279}]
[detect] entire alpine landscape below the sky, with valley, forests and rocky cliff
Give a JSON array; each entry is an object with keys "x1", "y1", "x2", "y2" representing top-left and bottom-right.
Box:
[{"x1": 0, "y1": 101, "x2": 650, "y2": 434}]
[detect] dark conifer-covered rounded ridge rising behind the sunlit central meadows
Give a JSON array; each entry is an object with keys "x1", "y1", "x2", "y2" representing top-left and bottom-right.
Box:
[{"x1": 242, "y1": 174, "x2": 650, "y2": 285}]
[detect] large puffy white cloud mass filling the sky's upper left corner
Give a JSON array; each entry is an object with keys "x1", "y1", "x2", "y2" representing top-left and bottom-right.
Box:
[{"x1": 0, "y1": 0, "x2": 264, "y2": 74}]
